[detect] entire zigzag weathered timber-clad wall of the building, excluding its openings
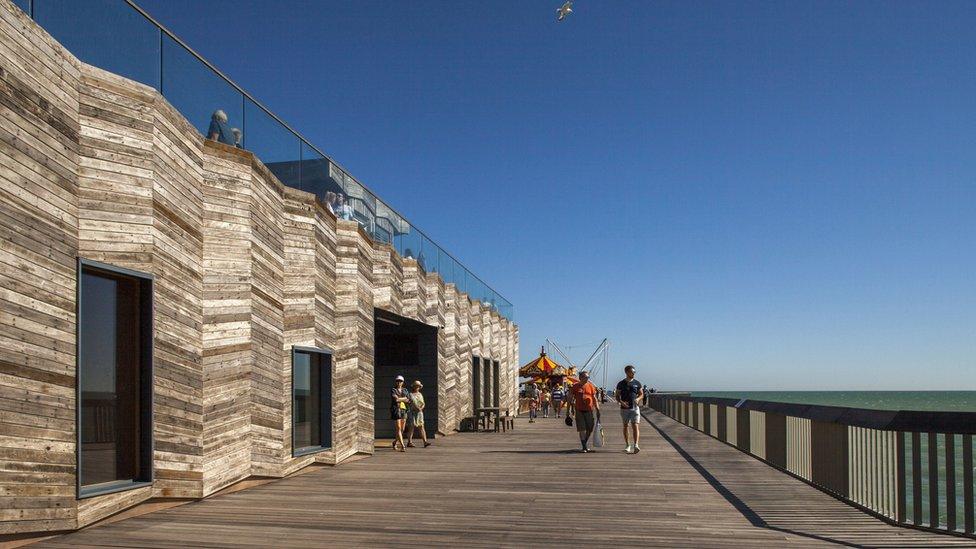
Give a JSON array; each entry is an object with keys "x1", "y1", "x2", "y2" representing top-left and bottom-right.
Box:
[{"x1": 0, "y1": 0, "x2": 518, "y2": 534}]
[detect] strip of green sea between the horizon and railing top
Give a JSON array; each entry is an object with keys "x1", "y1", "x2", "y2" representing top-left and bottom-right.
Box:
[{"x1": 691, "y1": 391, "x2": 976, "y2": 412}]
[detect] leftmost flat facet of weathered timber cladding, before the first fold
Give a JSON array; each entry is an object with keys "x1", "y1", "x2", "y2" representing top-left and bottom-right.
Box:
[{"x1": 0, "y1": 0, "x2": 80, "y2": 534}]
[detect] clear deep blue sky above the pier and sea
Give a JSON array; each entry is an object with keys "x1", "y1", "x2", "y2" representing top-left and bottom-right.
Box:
[{"x1": 133, "y1": 0, "x2": 976, "y2": 390}]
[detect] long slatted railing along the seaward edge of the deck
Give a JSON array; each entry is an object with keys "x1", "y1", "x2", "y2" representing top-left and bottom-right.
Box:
[{"x1": 650, "y1": 395, "x2": 976, "y2": 538}]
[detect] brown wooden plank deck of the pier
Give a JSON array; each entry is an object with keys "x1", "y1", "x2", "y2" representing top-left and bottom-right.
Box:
[{"x1": 36, "y1": 414, "x2": 976, "y2": 547}]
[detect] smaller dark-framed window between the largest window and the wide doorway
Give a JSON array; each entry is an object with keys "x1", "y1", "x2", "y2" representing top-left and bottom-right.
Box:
[{"x1": 291, "y1": 347, "x2": 332, "y2": 456}]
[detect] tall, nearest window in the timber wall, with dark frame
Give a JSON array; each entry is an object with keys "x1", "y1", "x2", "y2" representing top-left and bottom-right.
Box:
[{"x1": 77, "y1": 259, "x2": 153, "y2": 497}]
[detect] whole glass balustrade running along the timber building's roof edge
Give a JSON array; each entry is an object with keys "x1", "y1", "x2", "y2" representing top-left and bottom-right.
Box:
[{"x1": 14, "y1": 0, "x2": 515, "y2": 321}]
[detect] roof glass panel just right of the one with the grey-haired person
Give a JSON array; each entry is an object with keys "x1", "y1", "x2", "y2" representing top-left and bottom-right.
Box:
[{"x1": 243, "y1": 97, "x2": 302, "y2": 185}]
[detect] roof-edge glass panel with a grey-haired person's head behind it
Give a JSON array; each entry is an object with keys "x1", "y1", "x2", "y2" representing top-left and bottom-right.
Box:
[{"x1": 162, "y1": 36, "x2": 244, "y2": 146}]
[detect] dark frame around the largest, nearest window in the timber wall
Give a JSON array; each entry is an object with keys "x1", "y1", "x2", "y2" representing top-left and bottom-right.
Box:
[{"x1": 75, "y1": 257, "x2": 156, "y2": 500}]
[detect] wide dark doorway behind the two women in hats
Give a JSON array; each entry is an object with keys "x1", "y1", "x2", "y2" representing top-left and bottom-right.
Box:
[{"x1": 373, "y1": 309, "x2": 437, "y2": 438}]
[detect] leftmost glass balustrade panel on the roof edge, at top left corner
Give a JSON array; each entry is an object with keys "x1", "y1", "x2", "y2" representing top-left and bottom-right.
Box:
[{"x1": 33, "y1": 0, "x2": 160, "y2": 90}]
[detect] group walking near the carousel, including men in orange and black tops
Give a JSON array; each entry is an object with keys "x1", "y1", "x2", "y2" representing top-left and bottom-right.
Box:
[{"x1": 525, "y1": 365, "x2": 647, "y2": 454}]
